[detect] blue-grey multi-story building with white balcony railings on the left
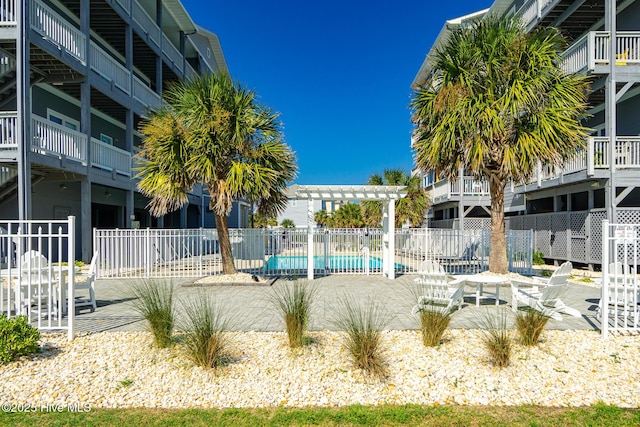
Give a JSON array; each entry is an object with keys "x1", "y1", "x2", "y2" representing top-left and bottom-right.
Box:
[{"x1": 0, "y1": 0, "x2": 241, "y2": 261}]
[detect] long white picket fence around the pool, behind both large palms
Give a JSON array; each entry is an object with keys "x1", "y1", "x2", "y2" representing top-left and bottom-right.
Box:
[{"x1": 94, "y1": 228, "x2": 533, "y2": 278}]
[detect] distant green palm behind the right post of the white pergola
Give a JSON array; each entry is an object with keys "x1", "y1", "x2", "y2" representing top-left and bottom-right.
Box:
[{"x1": 362, "y1": 169, "x2": 429, "y2": 227}]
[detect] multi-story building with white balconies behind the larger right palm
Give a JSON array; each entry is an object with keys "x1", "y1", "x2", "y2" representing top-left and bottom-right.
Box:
[{"x1": 412, "y1": 0, "x2": 640, "y2": 265}]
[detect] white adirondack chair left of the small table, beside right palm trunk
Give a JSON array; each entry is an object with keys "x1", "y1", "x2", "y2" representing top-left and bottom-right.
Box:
[{"x1": 411, "y1": 260, "x2": 465, "y2": 314}]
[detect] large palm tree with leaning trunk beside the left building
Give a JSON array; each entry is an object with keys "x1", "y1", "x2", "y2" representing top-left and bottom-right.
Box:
[{"x1": 138, "y1": 74, "x2": 296, "y2": 274}]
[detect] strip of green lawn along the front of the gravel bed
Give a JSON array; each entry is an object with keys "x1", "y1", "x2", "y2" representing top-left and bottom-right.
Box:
[{"x1": 0, "y1": 405, "x2": 640, "y2": 427}]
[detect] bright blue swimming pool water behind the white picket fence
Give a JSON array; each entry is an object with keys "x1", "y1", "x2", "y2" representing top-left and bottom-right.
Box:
[{"x1": 265, "y1": 255, "x2": 403, "y2": 270}]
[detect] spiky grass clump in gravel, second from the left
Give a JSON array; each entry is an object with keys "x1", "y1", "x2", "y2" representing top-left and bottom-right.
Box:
[{"x1": 181, "y1": 292, "x2": 229, "y2": 368}]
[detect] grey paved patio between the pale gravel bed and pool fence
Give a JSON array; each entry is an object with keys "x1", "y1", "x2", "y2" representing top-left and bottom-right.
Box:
[{"x1": 75, "y1": 275, "x2": 600, "y2": 332}]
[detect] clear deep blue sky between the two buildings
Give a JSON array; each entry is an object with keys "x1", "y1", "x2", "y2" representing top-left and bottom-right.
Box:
[{"x1": 182, "y1": 0, "x2": 493, "y2": 184}]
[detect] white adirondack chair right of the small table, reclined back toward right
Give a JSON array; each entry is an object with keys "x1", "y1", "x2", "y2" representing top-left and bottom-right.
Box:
[{"x1": 511, "y1": 261, "x2": 581, "y2": 320}]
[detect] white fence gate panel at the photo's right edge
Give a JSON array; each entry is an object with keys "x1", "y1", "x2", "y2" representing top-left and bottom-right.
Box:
[{"x1": 598, "y1": 220, "x2": 640, "y2": 338}]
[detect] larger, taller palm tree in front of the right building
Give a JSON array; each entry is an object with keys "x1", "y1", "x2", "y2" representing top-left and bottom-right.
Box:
[{"x1": 411, "y1": 17, "x2": 589, "y2": 273}]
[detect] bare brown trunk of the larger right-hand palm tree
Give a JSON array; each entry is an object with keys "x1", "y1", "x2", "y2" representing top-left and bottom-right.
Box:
[{"x1": 489, "y1": 176, "x2": 509, "y2": 274}]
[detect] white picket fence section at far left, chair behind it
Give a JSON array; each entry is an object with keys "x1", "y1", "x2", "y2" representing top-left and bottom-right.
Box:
[{"x1": 0, "y1": 216, "x2": 75, "y2": 339}]
